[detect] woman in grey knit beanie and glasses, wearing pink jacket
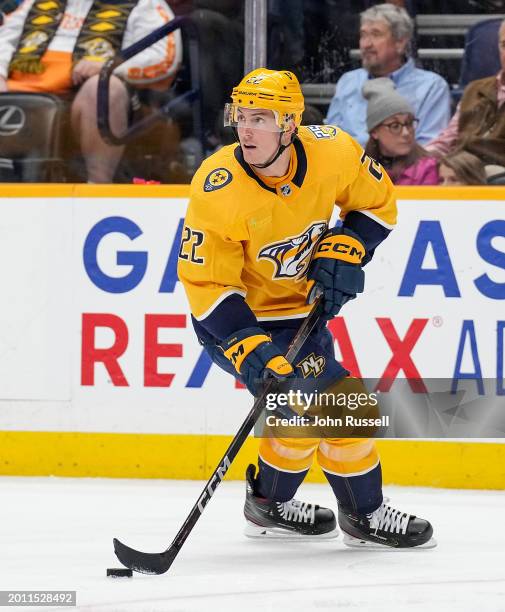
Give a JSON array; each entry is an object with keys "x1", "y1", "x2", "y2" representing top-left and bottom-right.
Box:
[{"x1": 363, "y1": 77, "x2": 438, "y2": 185}]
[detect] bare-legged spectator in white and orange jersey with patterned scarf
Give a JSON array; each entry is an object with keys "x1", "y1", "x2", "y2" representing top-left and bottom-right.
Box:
[{"x1": 0, "y1": 0, "x2": 181, "y2": 183}]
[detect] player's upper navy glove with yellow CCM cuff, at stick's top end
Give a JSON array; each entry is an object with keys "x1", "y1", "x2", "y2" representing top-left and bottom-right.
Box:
[{"x1": 307, "y1": 227, "x2": 366, "y2": 319}]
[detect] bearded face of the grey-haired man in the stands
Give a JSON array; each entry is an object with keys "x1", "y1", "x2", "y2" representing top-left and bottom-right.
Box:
[{"x1": 359, "y1": 19, "x2": 407, "y2": 76}]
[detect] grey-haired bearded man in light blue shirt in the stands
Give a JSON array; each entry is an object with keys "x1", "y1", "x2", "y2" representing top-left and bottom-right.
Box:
[{"x1": 326, "y1": 3, "x2": 450, "y2": 145}]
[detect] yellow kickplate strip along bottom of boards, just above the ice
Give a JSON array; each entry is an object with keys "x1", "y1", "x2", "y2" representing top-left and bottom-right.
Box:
[{"x1": 0, "y1": 431, "x2": 505, "y2": 489}]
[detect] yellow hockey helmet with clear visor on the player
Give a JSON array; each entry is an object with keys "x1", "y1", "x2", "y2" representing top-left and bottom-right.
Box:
[{"x1": 224, "y1": 68, "x2": 305, "y2": 131}]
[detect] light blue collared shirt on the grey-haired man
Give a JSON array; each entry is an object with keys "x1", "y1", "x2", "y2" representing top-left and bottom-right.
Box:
[{"x1": 325, "y1": 58, "x2": 451, "y2": 147}]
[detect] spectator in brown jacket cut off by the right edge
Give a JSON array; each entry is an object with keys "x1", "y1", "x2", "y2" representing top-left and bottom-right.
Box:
[{"x1": 426, "y1": 20, "x2": 505, "y2": 166}]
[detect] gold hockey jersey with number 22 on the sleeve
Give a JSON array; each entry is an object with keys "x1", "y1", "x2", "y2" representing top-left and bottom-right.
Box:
[{"x1": 178, "y1": 125, "x2": 396, "y2": 322}]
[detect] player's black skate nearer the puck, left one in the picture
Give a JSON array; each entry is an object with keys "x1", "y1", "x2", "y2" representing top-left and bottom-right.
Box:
[{"x1": 244, "y1": 465, "x2": 338, "y2": 540}]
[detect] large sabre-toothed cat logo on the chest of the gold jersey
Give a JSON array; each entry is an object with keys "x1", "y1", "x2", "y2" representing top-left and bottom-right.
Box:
[{"x1": 258, "y1": 221, "x2": 327, "y2": 280}]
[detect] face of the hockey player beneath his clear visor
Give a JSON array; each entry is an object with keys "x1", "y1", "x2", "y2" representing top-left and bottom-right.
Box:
[{"x1": 237, "y1": 108, "x2": 279, "y2": 164}]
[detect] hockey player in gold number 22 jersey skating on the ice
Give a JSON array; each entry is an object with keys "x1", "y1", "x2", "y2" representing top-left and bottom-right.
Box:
[{"x1": 178, "y1": 68, "x2": 434, "y2": 548}]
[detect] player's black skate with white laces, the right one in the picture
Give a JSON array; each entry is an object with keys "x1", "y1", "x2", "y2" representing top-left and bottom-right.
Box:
[{"x1": 338, "y1": 502, "x2": 437, "y2": 549}]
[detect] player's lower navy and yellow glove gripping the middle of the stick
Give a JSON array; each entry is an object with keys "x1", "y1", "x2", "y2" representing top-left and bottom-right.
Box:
[{"x1": 221, "y1": 327, "x2": 294, "y2": 397}]
